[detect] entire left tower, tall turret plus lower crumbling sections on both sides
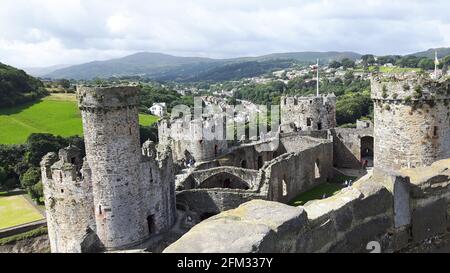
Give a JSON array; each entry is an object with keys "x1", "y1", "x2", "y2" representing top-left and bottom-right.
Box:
[{"x1": 42, "y1": 86, "x2": 175, "y2": 252}]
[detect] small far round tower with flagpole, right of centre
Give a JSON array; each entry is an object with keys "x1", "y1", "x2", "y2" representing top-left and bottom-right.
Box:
[{"x1": 281, "y1": 94, "x2": 336, "y2": 132}]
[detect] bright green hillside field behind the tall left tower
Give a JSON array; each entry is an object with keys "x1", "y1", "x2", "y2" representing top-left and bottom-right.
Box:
[{"x1": 0, "y1": 94, "x2": 158, "y2": 144}]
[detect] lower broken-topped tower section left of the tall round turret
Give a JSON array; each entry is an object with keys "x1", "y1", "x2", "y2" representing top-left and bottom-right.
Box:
[{"x1": 41, "y1": 150, "x2": 96, "y2": 253}]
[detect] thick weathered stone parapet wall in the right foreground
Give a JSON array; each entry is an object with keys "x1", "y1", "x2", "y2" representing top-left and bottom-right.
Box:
[{"x1": 164, "y1": 159, "x2": 450, "y2": 253}]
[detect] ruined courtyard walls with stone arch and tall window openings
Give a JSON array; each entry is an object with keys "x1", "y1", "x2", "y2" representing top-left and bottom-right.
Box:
[{"x1": 177, "y1": 135, "x2": 333, "y2": 217}]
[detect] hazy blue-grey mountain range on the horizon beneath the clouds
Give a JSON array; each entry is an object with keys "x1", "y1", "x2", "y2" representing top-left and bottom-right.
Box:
[{"x1": 37, "y1": 48, "x2": 450, "y2": 82}]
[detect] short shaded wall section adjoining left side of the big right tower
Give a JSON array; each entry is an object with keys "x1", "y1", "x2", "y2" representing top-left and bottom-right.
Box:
[{"x1": 330, "y1": 128, "x2": 373, "y2": 169}]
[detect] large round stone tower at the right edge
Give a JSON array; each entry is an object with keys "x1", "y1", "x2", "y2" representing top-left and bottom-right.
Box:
[{"x1": 371, "y1": 73, "x2": 450, "y2": 170}]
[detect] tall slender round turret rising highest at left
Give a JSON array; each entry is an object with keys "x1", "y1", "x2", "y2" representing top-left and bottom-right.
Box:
[{"x1": 77, "y1": 86, "x2": 148, "y2": 249}]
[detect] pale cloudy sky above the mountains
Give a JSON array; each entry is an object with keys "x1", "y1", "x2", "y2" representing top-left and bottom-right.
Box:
[{"x1": 0, "y1": 0, "x2": 450, "y2": 68}]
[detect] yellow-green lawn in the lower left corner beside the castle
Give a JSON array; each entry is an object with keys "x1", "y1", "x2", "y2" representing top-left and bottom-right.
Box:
[{"x1": 0, "y1": 193, "x2": 44, "y2": 229}]
